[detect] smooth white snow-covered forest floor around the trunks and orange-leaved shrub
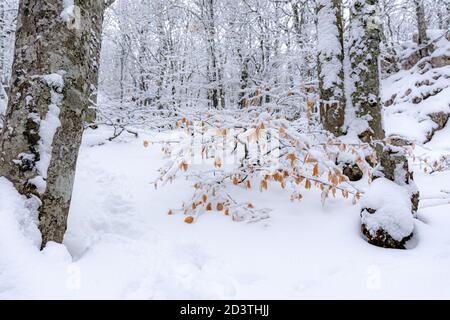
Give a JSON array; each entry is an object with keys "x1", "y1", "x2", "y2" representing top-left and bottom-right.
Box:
[{"x1": 0, "y1": 125, "x2": 450, "y2": 299}]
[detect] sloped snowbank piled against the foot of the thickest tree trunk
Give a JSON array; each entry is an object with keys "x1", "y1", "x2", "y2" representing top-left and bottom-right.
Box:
[{"x1": 0, "y1": 178, "x2": 72, "y2": 299}]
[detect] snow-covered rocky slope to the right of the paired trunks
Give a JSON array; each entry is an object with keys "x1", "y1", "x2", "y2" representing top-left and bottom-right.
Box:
[{"x1": 382, "y1": 30, "x2": 450, "y2": 143}]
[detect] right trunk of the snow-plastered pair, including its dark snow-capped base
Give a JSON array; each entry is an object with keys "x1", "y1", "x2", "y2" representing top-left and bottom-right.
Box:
[{"x1": 350, "y1": 0, "x2": 419, "y2": 248}]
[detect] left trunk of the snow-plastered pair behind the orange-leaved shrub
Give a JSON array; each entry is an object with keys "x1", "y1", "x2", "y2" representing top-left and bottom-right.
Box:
[{"x1": 317, "y1": 0, "x2": 346, "y2": 136}]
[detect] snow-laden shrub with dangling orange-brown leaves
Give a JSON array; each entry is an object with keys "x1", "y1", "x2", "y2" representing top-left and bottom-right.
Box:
[{"x1": 149, "y1": 109, "x2": 374, "y2": 223}]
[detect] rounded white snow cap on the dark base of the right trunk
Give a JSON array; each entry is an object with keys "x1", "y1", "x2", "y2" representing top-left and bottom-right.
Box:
[{"x1": 361, "y1": 178, "x2": 414, "y2": 241}]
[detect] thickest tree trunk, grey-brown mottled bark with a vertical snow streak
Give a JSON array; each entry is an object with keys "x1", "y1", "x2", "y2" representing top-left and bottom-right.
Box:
[{"x1": 0, "y1": 0, "x2": 112, "y2": 247}]
